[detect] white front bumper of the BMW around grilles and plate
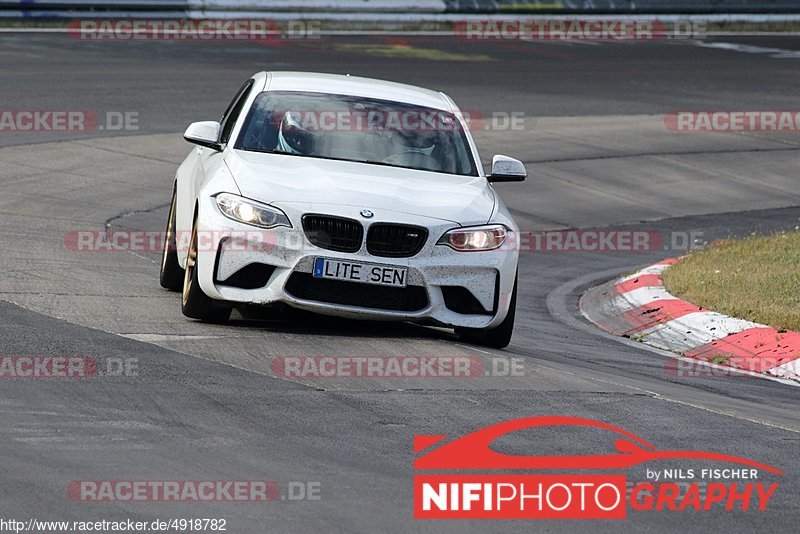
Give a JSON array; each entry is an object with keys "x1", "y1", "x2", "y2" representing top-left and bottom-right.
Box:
[{"x1": 192, "y1": 197, "x2": 518, "y2": 328}]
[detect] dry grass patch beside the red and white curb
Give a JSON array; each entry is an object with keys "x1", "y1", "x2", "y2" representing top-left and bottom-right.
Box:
[{"x1": 664, "y1": 231, "x2": 800, "y2": 331}]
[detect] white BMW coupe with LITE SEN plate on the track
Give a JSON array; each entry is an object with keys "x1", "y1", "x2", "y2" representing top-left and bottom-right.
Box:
[{"x1": 160, "y1": 72, "x2": 526, "y2": 348}]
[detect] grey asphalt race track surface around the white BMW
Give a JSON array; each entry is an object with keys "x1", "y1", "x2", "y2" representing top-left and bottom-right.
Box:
[{"x1": 0, "y1": 33, "x2": 800, "y2": 533}]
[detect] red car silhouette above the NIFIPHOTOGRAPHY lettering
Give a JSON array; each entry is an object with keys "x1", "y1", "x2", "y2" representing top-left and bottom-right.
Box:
[{"x1": 414, "y1": 417, "x2": 783, "y2": 475}]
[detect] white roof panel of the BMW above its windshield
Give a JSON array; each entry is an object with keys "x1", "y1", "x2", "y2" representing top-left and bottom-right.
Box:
[{"x1": 254, "y1": 71, "x2": 454, "y2": 111}]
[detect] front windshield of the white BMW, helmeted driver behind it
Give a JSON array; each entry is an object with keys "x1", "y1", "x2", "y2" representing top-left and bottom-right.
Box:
[{"x1": 235, "y1": 91, "x2": 478, "y2": 176}]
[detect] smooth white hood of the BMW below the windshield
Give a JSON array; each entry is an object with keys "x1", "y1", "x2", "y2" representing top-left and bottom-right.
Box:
[{"x1": 225, "y1": 151, "x2": 495, "y2": 225}]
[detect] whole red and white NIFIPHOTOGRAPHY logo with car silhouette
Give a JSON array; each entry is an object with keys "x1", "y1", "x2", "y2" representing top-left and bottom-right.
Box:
[{"x1": 414, "y1": 417, "x2": 783, "y2": 520}]
